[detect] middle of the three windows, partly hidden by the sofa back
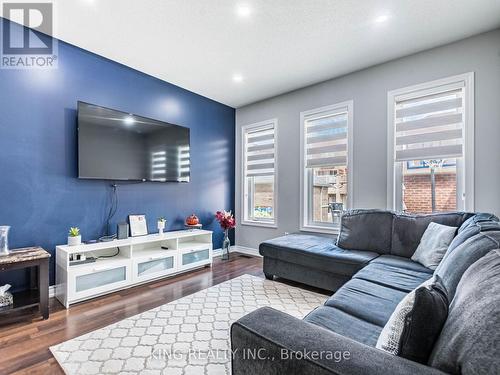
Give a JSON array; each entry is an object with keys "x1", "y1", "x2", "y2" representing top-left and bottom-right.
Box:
[{"x1": 300, "y1": 101, "x2": 353, "y2": 233}]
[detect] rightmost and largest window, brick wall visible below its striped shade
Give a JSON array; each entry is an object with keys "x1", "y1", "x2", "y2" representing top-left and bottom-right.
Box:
[{"x1": 388, "y1": 73, "x2": 474, "y2": 213}]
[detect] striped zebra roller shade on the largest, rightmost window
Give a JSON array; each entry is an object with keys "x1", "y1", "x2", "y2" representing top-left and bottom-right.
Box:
[{"x1": 395, "y1": 85, "x2": 464, "y2": 161}]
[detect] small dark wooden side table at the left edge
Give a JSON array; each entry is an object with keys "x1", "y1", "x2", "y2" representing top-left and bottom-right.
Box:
[{"x1": 0, "y1": 247, "x2": 50, "y2": 323}]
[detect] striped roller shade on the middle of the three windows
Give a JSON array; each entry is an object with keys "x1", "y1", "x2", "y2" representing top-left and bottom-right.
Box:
[{"x1": 304, "y1": 108, "x2": 348, "y2": 168}]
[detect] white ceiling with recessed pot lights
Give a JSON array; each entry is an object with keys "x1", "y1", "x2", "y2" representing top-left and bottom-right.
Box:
[{"x1": 3, "y1": 0, "x2": 500, "y2": 107}]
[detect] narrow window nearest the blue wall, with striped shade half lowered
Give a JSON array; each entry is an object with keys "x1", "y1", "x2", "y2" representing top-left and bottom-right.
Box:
[{"x1": 242, "y1": 120, "x2": 277, "y2": 227}]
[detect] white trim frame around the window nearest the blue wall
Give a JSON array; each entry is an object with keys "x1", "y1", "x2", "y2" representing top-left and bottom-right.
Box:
[{"x1": 240, "y1": 118, "x2": 278, "y2": 228}]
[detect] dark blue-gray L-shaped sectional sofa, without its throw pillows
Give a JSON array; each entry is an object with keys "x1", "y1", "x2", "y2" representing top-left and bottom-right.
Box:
[{"x1": 231, "y1": 210, "x2": 500, "y2": 375}]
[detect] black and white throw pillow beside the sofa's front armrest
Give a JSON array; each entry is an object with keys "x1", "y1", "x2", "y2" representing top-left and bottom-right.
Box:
[{"x1": 376, "y1": 276, "x2": 448, "y2": 363}]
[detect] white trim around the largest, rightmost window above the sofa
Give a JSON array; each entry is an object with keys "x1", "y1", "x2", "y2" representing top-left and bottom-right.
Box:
[{"x1": 387, "y1": 72, "x2": 474, "y2": 212}]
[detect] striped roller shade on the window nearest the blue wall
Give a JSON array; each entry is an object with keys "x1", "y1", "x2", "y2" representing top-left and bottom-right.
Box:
[{"x1": 245, "y1": 124, "x2": 275, "y2": 177}]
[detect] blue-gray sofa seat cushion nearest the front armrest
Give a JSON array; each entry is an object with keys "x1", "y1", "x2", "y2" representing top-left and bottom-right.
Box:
[{"x1": 304, "y1": 306, "x2": 382, "y2": 346}]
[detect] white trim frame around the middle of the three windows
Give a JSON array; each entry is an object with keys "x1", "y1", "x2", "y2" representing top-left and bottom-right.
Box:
[{"x1": 299, "y1": 100, "x2": 354, "y2": 234}]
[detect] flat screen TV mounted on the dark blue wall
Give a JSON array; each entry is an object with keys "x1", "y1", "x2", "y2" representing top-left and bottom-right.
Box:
[{"x1": 78, "y1": 102, "x2": 190, "y2": 182}]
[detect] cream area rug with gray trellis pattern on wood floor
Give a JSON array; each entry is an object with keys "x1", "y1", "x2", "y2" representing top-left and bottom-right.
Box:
[{"x1": 50, "y1": 275, "x2": 326, "y2": 375}]
